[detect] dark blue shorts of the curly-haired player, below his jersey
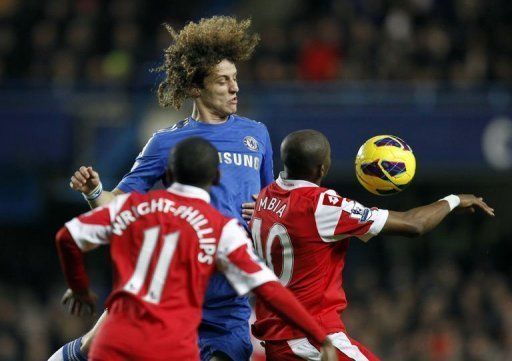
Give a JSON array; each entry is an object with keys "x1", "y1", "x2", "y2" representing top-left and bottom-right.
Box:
[{"x1": 199, "y1": 322, "x2": 252, "y2": 361}]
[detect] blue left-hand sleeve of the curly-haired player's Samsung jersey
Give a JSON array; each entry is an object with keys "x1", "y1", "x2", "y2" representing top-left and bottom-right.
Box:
[{"x1": 117, "y1": 133, "x2": 166, "y2": 193}]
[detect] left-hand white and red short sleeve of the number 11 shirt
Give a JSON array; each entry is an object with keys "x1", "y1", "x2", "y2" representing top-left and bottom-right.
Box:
[{"x1": 66, "y1": 194, "x2": 130, "y2": 251}]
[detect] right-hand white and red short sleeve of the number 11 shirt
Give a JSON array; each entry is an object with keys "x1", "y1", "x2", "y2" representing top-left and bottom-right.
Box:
[{"x1": 217, "y1": 219, "x2": 277, "y2": 295}]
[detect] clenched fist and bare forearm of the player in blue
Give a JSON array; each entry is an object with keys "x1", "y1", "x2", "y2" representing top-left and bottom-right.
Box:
[{"x1": 69, "y1": 166, "x2": 123, "y2": 208}]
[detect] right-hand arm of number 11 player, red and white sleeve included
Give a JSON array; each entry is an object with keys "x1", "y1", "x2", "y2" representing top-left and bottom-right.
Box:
[{"x1": 217, "y1": 220, "x2": 336, "y2": 360}]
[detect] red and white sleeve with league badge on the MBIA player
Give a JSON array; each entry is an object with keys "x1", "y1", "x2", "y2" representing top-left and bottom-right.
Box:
[{"x1": 315, "y1": 190, "x2": 388, "y2": 242}]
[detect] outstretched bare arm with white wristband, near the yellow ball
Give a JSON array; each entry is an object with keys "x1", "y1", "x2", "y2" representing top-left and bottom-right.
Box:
[{"x1": 380, "y1": 194, "x2": 494, "y2": 237}]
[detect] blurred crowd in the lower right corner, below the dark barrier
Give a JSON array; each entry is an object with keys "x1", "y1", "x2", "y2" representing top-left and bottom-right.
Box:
[{"x1": 345, "y1": 262, "x2": 512, "y2": 361}]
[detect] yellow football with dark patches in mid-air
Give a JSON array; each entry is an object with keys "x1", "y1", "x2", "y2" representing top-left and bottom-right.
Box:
[{"x1": 355, "y1": 135, "x2": 416, "y2": 196}]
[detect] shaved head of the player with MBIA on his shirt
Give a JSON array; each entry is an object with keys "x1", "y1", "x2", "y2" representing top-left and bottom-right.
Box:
[{"x1": 281, "y1": 129, "x2": 331, "y2": 183}]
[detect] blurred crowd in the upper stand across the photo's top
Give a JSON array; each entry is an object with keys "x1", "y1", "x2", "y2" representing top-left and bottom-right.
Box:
[{"x1": 0, "y1": 0, "x2": 512, "y2": 85}]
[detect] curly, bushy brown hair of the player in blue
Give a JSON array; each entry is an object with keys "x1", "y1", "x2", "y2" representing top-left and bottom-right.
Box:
[{"x1": 156, "y1": 16, "x2": 260, "y2": 109}]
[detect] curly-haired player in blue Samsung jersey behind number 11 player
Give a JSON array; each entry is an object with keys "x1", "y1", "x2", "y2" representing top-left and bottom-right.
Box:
[{"x1": 50, "y1": 17, "x2": 274, "y2": 361}]
